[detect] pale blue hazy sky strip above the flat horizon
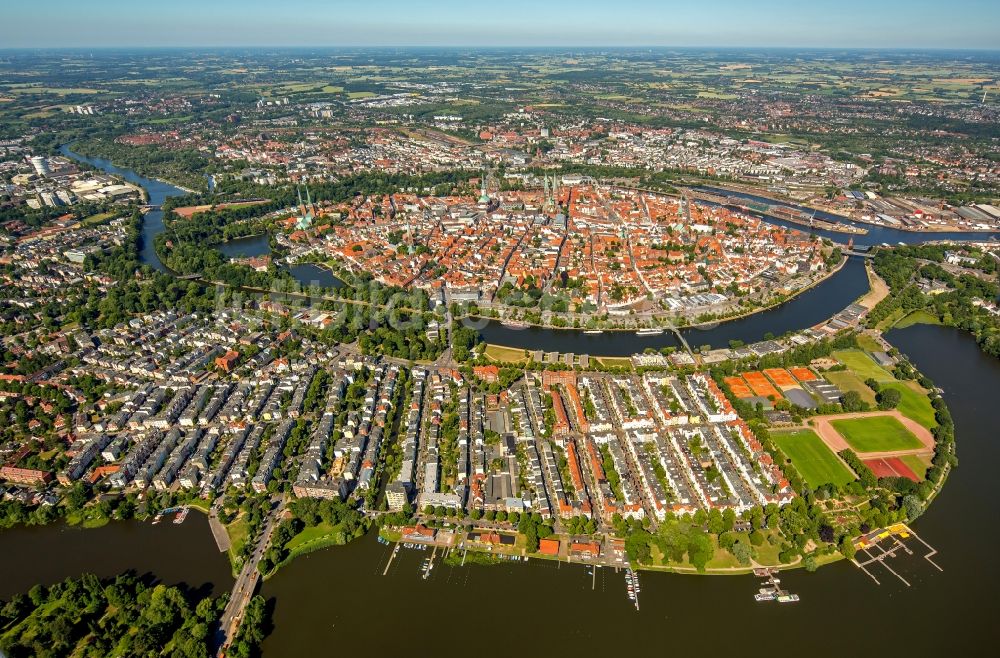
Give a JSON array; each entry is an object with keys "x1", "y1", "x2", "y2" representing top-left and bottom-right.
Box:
[{"x1": 0, "y1": 0, "x2": 1000, "y2": 50}]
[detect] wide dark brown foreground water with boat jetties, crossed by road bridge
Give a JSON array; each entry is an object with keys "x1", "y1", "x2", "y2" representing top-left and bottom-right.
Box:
[{"x1": 0, "y1": 325, "x2": 1000, "y2": 658}]
